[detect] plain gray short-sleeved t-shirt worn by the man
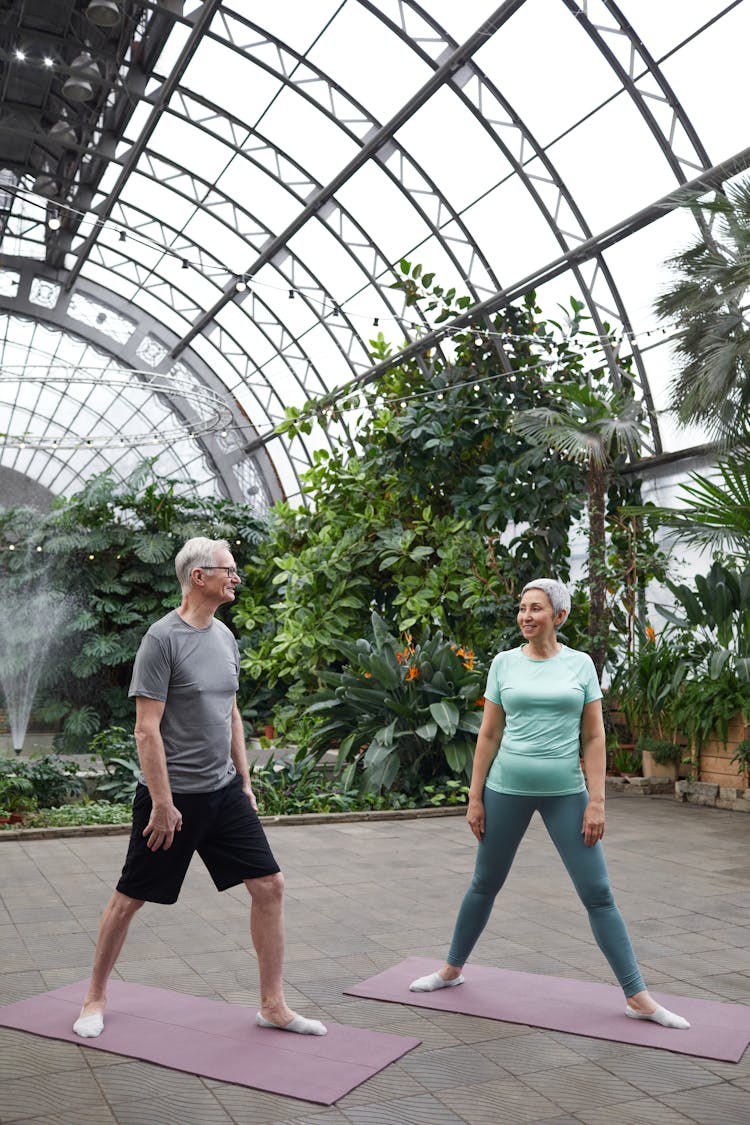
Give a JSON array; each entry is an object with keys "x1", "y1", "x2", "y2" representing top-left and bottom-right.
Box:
[{"x1": 128, "y1": 610, "x2": 240, "y2": 793}]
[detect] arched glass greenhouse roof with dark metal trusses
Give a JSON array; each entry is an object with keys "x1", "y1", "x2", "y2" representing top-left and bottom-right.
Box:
[{"x1": 0, "y1": 0, "x2": 750, "y2": 510}]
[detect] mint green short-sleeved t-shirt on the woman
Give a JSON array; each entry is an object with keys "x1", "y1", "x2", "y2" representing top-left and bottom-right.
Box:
[{"x1": 485, "y1": 645, "x2": 602, "y2": 797}]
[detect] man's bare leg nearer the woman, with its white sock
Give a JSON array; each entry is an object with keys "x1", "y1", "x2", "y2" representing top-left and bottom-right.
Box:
[{"x1": 245, "y1": 872, "x2": 325, "y2": 1035}]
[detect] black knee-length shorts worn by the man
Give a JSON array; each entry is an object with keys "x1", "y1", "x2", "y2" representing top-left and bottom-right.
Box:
[{"x1": 117, "y1": 774, "x2": 280, "y2": 903}]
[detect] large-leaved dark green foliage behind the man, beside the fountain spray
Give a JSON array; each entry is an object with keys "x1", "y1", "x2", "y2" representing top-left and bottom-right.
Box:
[{"x1": 0, "y1": 461, "x2": 262, "y2": 752}]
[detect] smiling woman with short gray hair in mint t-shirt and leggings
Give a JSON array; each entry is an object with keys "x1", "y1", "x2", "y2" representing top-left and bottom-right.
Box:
[{"x1": 409, "y1": 578, "x2": 690, "y2": 1028}]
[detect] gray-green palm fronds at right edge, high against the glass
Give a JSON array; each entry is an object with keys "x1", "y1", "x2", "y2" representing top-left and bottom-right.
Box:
[{"x1": 654, "y1": 180, "x2": 750, "y2": 444}]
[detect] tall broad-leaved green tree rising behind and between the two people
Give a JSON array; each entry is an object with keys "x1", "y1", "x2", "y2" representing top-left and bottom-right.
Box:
[{"x1": 234, "y1": 285, "x2": 611, "y2": 720}]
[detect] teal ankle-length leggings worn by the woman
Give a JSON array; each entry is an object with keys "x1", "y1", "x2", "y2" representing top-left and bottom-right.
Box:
[{"x1": 448, "y1": 789, "x2": 645, "y2": 997}]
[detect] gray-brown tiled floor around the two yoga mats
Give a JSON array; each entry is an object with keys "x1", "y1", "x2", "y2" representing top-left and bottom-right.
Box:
[{"x1": 0, "y1": 795, "x2": 750, "y2": 1125}]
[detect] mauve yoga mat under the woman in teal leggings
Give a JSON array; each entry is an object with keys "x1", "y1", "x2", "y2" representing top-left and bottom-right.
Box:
[{"x1": 345, "y1": 957, "x2": 750, "y2": 1062}]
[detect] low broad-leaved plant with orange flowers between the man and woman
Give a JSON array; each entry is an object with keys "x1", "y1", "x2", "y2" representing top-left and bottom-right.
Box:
[{"x1": 307, "y1": 612, "x2": 485, "y2": 793}]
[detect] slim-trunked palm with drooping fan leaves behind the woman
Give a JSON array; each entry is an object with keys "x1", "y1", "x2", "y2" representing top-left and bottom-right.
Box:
[{"x1": 510, "y1": 384, "x2": 643, "y2": 676}]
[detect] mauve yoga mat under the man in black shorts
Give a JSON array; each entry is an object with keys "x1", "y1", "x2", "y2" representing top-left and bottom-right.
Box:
[{"x1": 0, "y1": 981, "x2": 421, "y2": 1106}]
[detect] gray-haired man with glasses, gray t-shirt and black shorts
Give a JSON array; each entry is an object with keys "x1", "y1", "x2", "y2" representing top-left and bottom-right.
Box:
[{"x1": 73, "y1": 538, "x2": 326, "y2": 1038}]
